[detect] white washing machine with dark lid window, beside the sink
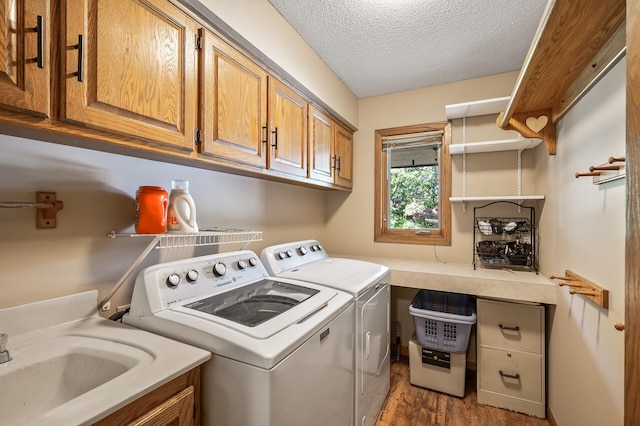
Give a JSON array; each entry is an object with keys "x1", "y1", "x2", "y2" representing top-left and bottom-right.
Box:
[{"x1": 123, "y1": 250, "x2": 354, "y2": 426}]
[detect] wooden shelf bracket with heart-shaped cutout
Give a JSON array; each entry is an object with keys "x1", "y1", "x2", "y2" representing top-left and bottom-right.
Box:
[{"x1": 496, "y1": 108, "x2": 556, "y2": 155}]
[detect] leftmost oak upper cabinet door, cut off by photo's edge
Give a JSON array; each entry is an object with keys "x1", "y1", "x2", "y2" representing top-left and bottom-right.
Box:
[{"x1": 0, "y1": 0, "x2": 51, "y2": 117}]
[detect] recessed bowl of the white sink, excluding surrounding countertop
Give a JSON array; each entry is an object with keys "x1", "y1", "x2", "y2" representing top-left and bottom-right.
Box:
[{"x1": 0, "y1": 335, "x2": 154, "y2": 424}]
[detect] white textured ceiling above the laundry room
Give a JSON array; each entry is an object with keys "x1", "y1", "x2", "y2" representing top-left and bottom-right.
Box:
[{"x1": 269, "y1": 0, "x2": 547, "y2": 98}]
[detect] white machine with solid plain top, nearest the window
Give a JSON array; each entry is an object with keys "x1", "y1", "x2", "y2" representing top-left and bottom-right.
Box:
[{"x1": 260, "y1": 240, "x2": 390, "y2": 426}]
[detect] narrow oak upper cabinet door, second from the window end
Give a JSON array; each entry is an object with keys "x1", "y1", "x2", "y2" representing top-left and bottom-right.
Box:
[{"x1": 308, "y1": 105, "x2": 335, "y2": 183}]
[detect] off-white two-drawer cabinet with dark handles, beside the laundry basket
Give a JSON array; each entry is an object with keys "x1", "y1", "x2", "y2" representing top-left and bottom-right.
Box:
[{"x1": 477, "y1": 298, "x2": 546, "y2": 418}]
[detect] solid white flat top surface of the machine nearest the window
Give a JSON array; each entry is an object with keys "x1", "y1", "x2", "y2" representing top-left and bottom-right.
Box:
[{"x1": 278, "y1": 257, "x2": 389, "y2": 297}]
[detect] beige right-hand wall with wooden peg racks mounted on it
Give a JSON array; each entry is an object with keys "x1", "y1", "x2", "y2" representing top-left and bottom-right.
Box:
[{"x1": 536, "y1": 61, "x2": 625, "y2": 426}]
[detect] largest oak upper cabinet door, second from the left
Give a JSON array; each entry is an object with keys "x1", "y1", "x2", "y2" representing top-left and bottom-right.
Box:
[{"x1": 62, "y1": 0, "x2": 198, "y2": 151}]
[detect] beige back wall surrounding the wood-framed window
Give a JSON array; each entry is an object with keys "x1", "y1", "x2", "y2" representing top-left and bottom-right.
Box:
[{"x1": 325, "y1": 72, "x2": 535, "y2": 263}]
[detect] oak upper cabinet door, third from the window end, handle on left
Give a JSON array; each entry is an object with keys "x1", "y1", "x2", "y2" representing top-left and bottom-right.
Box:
[{"x1": 268, "y1": 77, "x2": 307, "y2": 177}]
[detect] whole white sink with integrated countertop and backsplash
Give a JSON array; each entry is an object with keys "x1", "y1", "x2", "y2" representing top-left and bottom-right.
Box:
[{"x1": 0, "y1": 291, "x2": 211, "y2": 426}]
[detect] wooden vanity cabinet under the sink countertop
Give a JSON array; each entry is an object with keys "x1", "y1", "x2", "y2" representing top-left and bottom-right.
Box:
[{"x1": 94, "y1": 367, "x2": 200, "y2": 426}]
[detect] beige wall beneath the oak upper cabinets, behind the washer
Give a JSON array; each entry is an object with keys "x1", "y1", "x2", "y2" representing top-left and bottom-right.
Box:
[{"x1": 0, "y1": 135, "x2": 325, "y2": 307}]
